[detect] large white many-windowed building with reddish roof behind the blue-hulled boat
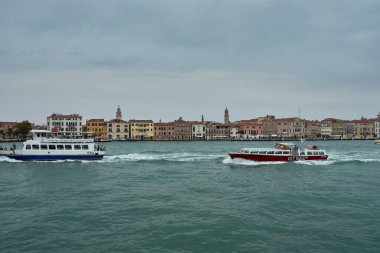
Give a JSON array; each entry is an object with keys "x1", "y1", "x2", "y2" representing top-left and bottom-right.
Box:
[{"x1": 47, "y1": 113, "x2": 82, "y2": 138}]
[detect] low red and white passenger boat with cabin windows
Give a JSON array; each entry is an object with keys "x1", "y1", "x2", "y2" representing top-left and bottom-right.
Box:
[{"x1": 228, "y1": 143, "x2": 328, "y2": 162}]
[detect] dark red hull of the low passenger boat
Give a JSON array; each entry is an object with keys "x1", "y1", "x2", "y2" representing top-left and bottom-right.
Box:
[{"x1": 228, "y1": 153, "x2": 328, "y2": 162}]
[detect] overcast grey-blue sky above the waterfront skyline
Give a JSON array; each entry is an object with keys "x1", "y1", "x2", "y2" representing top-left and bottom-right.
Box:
[{"x1": 0, "y1": 0, "x2": 380, "y2": 123}]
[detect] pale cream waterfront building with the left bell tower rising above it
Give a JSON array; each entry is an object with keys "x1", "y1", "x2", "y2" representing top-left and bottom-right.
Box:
[{"x1": 107, "y1": 106, "x2": 129, "y2": 141}]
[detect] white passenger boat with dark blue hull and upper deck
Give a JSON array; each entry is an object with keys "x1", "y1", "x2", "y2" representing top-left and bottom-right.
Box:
[{"x1": 0, "y1": 130, "x2": 105, "y2": 161}]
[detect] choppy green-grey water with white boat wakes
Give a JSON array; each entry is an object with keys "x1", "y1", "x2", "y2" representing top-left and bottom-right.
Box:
[{"x1": 0, "y1": 141, "x2": 380, "y2": 252}]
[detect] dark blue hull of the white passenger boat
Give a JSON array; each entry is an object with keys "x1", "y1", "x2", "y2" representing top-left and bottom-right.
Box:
[{"x1": 6, "y1": 155, "x2": 104, "y2": 161}]
